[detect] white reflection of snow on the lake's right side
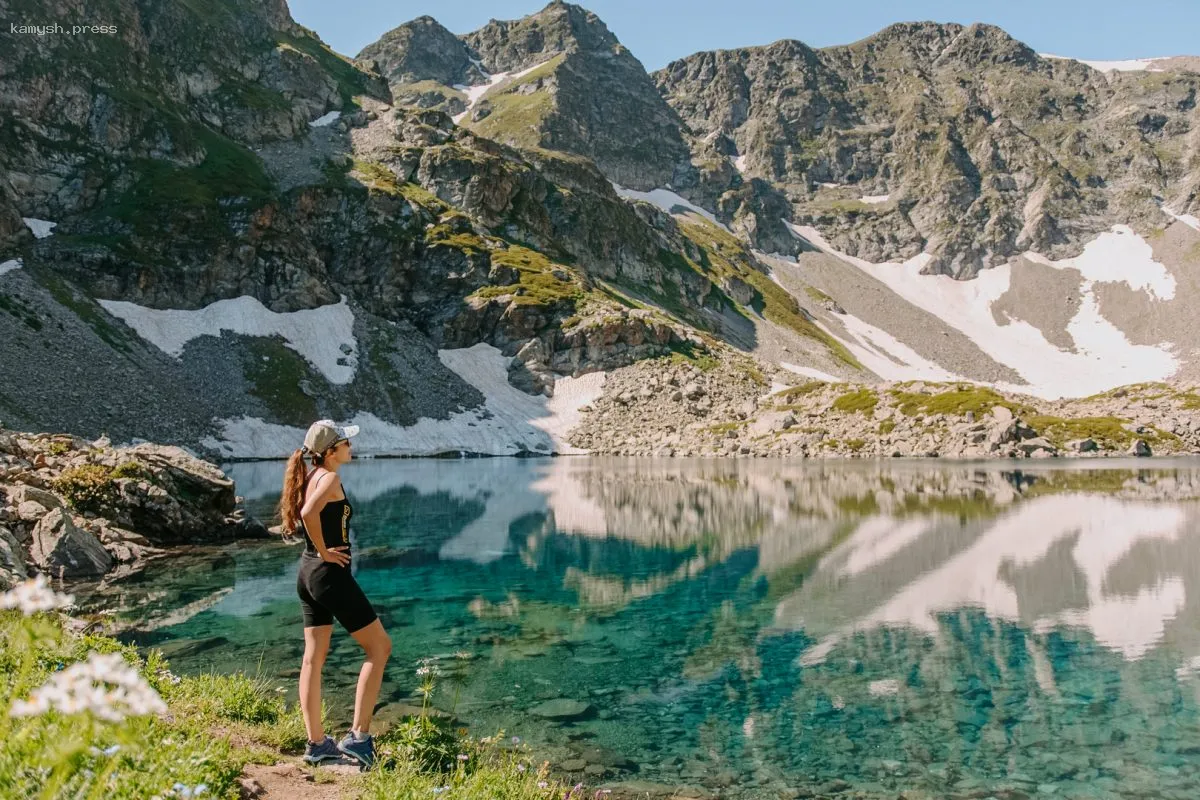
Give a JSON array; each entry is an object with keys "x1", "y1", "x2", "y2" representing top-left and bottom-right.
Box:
[{"x1": 780, "y1": 495, "x2": 1187, "y2": 664}]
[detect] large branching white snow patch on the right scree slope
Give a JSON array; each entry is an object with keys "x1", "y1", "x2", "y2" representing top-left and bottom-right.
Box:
[{"x1": 787, "y1": 223, "x2": 1178, "y2": 399}]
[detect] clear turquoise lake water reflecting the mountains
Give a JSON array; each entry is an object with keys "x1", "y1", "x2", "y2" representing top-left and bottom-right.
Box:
[{"x1": 84, "y1": 458, "x2": 1200, "y2": 799}]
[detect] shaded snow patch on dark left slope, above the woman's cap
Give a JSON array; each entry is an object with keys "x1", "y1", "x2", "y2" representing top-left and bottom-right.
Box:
[{"x1": 98, "y1": 296, "x2": 358, "y2": 383}]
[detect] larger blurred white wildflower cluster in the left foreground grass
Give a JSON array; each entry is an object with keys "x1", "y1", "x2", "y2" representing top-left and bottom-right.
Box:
[{"x1": 11, "y1": 652, "x2": 167, "y2": 722}]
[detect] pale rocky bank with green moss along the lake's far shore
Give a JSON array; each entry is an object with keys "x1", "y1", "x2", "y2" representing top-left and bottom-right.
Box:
[{"x1": 569, "y1": 356, "x2": 1200, "y2": 458}]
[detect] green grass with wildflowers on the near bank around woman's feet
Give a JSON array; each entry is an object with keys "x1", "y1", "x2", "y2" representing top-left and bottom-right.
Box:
[{"x1": 0, "y1": 610, "x2": 564, "y2": 800}]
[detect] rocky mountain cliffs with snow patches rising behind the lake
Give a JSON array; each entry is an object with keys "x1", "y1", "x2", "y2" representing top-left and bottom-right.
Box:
[{"x1": 0, "y1": 0, "x2": 1200, "y2": 457}]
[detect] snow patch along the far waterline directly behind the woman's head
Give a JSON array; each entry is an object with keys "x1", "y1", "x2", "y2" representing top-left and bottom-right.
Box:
[{"x1": 202, "y1": 344, "x2": 605, "y2": 458}]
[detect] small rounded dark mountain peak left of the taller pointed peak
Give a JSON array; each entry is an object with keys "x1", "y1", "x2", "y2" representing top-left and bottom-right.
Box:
[{"x1": 358, "y1": 16, "x2": 482, "y2": 86}]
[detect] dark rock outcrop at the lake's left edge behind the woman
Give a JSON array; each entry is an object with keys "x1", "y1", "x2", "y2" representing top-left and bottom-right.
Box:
[{"x1": 0, "y1": 428, "x2": 269, "y2": 590}]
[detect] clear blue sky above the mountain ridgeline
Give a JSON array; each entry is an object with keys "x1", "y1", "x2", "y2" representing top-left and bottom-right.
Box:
[{"x1": 289, "y1": 0, "x2": 1200, "y2": 70}]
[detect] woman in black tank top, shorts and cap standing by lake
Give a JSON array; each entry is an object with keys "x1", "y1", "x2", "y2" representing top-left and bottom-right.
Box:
[{"x1": 280, "y1": 420, "x2": 391, "y2": 768}]
